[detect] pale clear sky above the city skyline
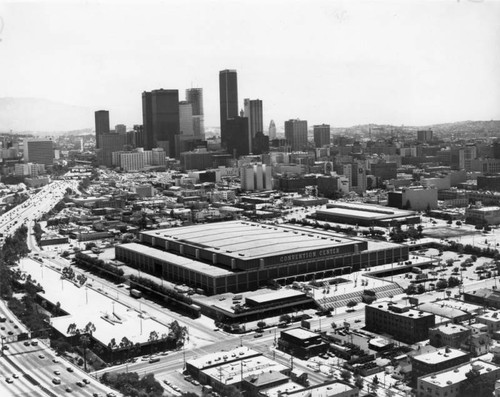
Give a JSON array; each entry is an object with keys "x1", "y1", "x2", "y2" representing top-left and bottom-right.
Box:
[{"x1": 0, "y1": 0, "x2": 500, "y2": 131}]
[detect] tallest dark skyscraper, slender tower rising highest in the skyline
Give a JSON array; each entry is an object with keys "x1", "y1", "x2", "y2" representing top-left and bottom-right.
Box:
[{"x1": 219, "y1": 69, "x2": 238, "y2": 146}]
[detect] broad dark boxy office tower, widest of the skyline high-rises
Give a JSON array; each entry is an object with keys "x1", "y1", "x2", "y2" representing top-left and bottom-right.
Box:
[{"x1": 142, "y1": 89, "x2": 180, "y2": 158}]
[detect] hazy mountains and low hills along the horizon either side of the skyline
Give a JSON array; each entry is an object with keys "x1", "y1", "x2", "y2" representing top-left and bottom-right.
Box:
[{"x1": 0, "y1": 97, "x2": 500, "y2": 135}]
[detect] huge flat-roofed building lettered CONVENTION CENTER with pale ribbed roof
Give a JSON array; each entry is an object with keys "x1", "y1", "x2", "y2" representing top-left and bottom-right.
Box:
[{"x1": 116, "y1": 221, "x2": 408, "y2": 294}]
